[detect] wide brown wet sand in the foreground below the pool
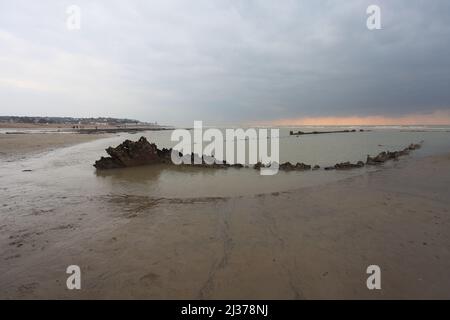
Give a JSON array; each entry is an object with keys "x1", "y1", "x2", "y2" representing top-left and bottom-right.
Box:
[{"x1": 0, "y1": 151, "x2": 450, "y2": 299}]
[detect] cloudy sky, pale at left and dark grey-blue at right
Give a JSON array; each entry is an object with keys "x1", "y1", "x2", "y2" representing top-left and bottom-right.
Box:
[{"x1": 0, "y1": 0, "x2": 450, "y2": 125}]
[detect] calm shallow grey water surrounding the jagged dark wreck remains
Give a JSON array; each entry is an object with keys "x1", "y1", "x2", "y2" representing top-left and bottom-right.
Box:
[{"x1": 0, "y1": 127, "x2": 450, "y2": 199}]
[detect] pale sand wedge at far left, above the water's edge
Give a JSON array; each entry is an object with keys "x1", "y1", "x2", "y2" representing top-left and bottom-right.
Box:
[{"x1": 0, "y1": 132, "x2": 108, "y2": 161}]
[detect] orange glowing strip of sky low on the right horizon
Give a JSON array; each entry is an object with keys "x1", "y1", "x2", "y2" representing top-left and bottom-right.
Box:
[{"x1": 266, "y1": 110, "x2": 450, "y2": 126}]
